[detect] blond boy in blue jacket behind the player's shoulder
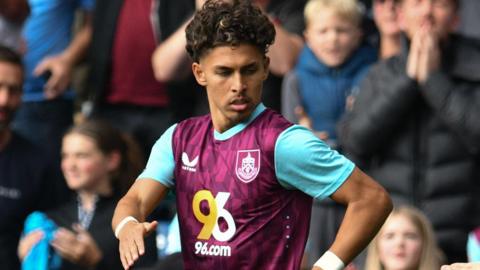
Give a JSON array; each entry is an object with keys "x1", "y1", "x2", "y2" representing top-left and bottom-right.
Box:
[{"x1": 282, "y1": 0, "x2": 377, "y2": 146}]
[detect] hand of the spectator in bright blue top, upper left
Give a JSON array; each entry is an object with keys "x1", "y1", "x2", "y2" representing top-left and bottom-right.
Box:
[{"x1": 33, "y1": 55, "x2": 73, "y2": 99}]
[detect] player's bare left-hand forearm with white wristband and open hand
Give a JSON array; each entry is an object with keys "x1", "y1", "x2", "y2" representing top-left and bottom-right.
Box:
[{"x1": 112, "y1": 179, "x2": 168, "y2": 269}]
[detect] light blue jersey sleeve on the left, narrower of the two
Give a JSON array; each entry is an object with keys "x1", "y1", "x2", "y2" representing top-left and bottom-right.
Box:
[{"x1": 138, "y1": 124, "x2": 177, "y2": 188}]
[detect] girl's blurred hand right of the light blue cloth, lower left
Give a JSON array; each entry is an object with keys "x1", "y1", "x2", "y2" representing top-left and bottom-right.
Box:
[{"x1": 51, "y1": 224, "x2": 103, "y2": 267}]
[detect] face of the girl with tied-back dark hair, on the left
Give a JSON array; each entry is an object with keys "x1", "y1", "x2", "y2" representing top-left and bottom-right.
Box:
[{"x1": 62, "y1": 133, "x2": 116, "y2": 192}]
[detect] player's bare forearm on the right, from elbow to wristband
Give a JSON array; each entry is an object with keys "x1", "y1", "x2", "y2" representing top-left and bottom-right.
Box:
[{"x1": 330, "y1": 186, "x2": 392, "y2": 265}]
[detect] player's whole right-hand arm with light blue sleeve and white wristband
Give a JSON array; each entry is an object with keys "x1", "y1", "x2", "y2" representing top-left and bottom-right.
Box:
[{"x1": 275, "y1": 125, "x2": 386, "y2": 270}]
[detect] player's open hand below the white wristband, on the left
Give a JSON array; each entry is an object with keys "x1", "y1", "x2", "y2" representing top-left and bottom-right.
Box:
[{"x1": 118, "y1": 221, "x2": 158, "y2": 269}]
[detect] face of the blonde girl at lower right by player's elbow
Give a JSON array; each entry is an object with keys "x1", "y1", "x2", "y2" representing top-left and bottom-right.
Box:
[{"x1": 378, "y1": 214, "x2": 423, "y2": 270}]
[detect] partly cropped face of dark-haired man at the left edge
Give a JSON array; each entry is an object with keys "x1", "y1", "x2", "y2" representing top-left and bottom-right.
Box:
[{"x1": 0, "y1": 62, "x2": 23, "y2": 131}]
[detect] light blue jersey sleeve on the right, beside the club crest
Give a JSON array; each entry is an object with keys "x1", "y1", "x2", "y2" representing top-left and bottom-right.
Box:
[{"x1": 274, "y1": 125, "x2": 355, "y2": 200}]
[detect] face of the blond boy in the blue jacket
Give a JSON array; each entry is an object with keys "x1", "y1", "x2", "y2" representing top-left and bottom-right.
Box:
[{"x1": 305, "y1": 9, "x2": 361, "y2": 67}]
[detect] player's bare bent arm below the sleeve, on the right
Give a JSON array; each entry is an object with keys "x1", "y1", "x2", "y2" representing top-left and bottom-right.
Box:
[{"x1": 314, "y1": 168, "x2": 392, "y2": 269}]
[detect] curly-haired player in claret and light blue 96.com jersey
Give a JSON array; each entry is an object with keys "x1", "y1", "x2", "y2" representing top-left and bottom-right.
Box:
[{"x1": 112, "y1": 0, "x2": 391, "y2": 269}]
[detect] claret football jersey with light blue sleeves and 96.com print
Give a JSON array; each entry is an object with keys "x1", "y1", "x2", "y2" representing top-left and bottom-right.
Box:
[{"x1": 139, "y1": 104, "x2": 354, "y2": 269}]
